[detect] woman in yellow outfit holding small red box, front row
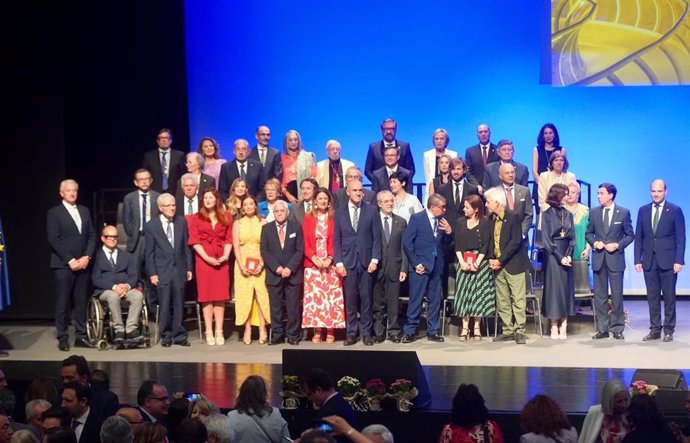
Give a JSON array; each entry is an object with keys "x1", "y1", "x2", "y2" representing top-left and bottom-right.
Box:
[{"x1": 232, "y1": 196, "x2": 271, "y2": 345}]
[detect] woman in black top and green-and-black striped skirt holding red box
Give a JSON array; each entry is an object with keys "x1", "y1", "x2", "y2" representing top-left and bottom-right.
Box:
[{"x1": 455, "y1": 195, "x2": 496, "y2": 341}]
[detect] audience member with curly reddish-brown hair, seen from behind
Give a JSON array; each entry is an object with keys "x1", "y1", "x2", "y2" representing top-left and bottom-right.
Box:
[{"x1": 520, "y1": 395, "x2": 577, "y2": 443}]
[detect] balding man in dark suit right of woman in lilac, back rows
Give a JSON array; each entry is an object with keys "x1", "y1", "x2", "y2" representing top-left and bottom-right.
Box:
[{"x1": 218, "y1": 138, "x2": 264, "y2": 201}]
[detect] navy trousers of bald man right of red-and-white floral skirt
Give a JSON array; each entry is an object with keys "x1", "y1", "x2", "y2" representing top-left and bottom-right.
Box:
[{"x1": 343, "y1": 264, "x2": 373, "y2": 337}]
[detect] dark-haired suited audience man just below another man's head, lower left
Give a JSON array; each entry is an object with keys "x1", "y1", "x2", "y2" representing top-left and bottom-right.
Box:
[{"x1": 62, "y1": 380, "x2": 107, "y2": 443}]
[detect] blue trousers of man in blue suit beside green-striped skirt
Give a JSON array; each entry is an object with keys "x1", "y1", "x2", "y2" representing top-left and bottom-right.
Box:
[{"x1": 404, "y1": 255, "x2": 446, "y2": 335}]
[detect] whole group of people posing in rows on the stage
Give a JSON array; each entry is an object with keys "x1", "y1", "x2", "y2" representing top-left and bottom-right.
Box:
[{"x1": 48, "y1": 119, "x2": 685, "y2": 350}]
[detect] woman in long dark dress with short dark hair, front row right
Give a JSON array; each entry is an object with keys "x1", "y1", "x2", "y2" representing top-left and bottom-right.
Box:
[{"x1": 541, "y1": 183, "x2": 575, "y2": 340}]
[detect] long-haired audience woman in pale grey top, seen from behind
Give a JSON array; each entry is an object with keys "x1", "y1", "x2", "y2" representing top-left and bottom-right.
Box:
[{"x1": 228, "y1": 375, "x2": 290, "y2": 443}]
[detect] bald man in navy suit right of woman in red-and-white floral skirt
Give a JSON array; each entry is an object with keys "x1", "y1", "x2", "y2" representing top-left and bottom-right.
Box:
[{"x1": 333, "y1": 179, "x2": 381, "y2": 346}]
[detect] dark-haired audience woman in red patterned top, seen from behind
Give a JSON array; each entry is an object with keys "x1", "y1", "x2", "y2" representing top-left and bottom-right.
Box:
[{"x1": 438, "y1": 383, "x2": 503, "y2": 443}]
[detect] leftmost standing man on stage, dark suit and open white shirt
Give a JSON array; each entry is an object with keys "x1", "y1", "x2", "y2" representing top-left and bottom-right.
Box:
[{"x1": 46, "y1": 179, "x2": 96, "y2": 351}]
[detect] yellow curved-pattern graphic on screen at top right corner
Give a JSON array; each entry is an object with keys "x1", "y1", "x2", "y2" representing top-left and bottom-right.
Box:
[{"x1": 551, "y1": 0, "x2": 690, "y2": 86}]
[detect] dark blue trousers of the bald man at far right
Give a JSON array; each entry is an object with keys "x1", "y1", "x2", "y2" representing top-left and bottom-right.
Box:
[{"x1": 644, "y1": 255, "x2": 678, "y2": 334}]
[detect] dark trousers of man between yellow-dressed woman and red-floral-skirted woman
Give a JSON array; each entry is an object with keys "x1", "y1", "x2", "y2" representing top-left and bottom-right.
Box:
[{"x1": 267, "y1": 279, "x2": 302, "y2": 340}]
